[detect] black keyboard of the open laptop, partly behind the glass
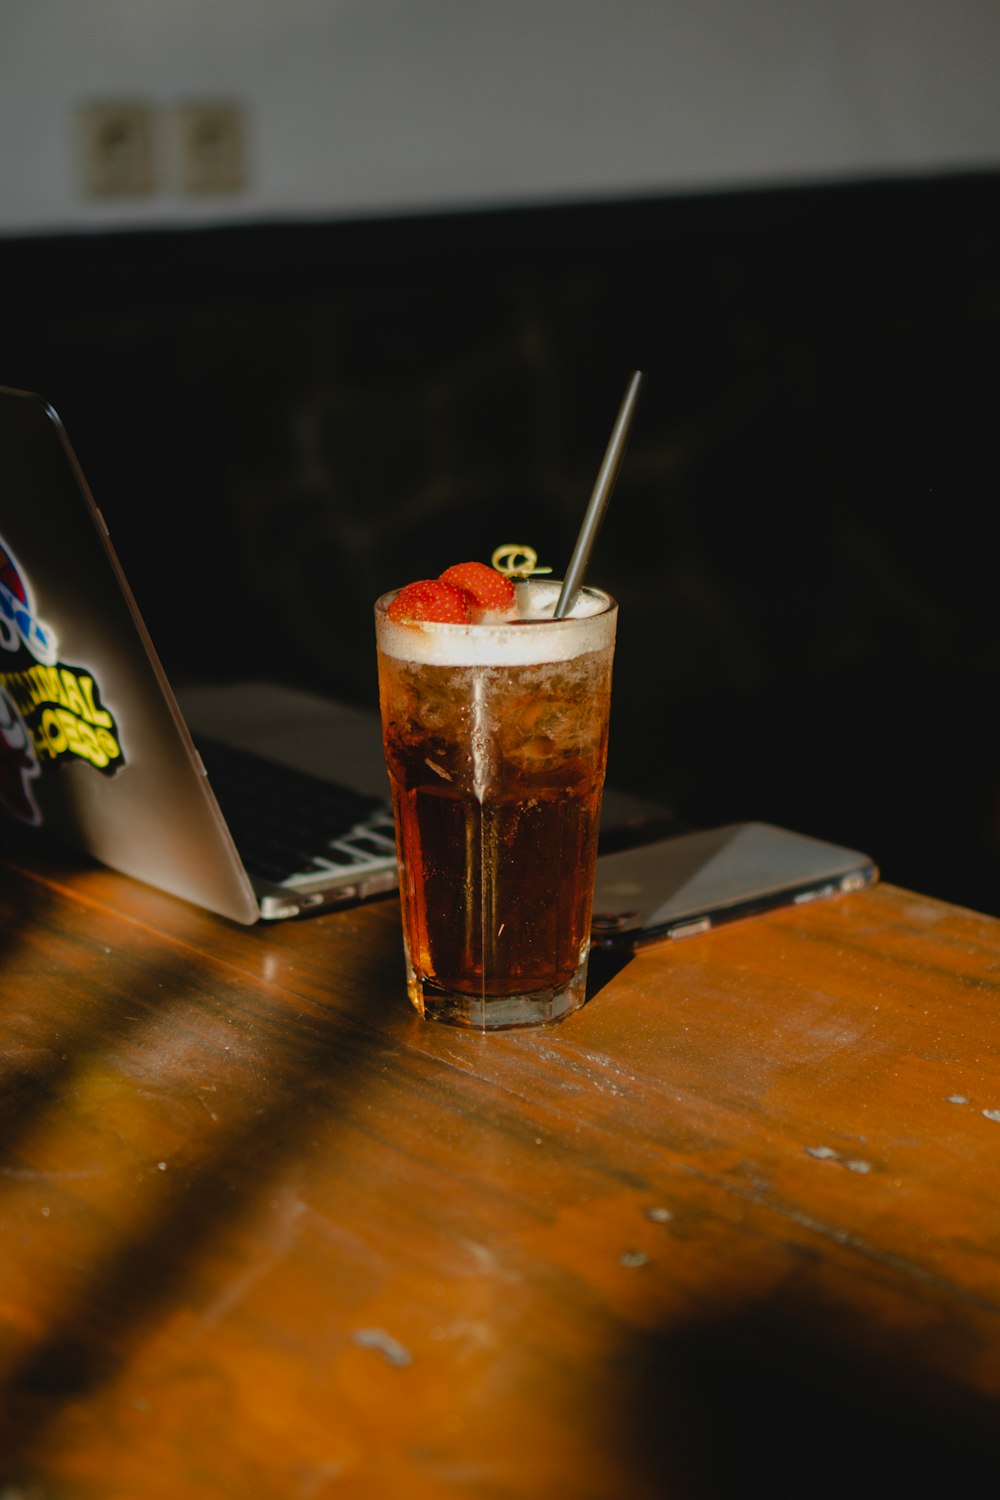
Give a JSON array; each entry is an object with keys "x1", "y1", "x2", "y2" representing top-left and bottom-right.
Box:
[{"x1": 196, "y1": 737, "x2": 396, "y2": 885}]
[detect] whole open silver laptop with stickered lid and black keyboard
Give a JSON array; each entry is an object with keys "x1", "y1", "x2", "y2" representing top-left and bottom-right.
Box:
[{"x1": 0, "y1": 387, "x2": 397, "y2": 926}]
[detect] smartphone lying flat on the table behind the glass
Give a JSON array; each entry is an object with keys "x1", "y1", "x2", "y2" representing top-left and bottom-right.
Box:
[{"x1": 591, "y1": 824, "x2": 879, "y2": 951}]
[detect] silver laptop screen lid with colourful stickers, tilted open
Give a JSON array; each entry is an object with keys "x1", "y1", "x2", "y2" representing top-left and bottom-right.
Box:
[{"x1": 0, "y1": 387, "x2": 396, "y2": 924}]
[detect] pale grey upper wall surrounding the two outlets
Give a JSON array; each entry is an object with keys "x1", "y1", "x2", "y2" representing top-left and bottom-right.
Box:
[{"x1": 0, "y1": 0, "x2": 1000, "y2": 233}]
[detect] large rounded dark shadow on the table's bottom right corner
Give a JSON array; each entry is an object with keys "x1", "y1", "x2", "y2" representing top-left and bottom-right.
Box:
[{"x1": 610, "y1": 1295, "x2": 1000, "y2": 1500}]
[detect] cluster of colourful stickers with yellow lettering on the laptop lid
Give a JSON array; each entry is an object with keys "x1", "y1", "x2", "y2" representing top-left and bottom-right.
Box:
[{"x1": 0, "y1": 537, "x2": 124, "y2": 824}]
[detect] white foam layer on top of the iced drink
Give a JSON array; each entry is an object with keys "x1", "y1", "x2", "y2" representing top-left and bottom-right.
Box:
[{"x1": 375, "y1": 579, "x2": 618, "y2": 666}]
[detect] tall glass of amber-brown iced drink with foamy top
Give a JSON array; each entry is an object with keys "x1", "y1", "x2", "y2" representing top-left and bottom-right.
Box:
[{"x1": 376, "y1": 581, "x2": 618, "y2": 1031}]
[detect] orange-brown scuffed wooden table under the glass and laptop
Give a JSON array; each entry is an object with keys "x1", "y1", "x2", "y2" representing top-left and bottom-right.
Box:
[{"x1": 0, "y1": 834, "x2": 1000, "y2": 1500}]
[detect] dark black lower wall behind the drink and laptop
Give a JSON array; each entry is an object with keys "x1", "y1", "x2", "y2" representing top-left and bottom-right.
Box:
[{"x1": 0, "y1": 174, "x2": 1000, "y2": 914}]
